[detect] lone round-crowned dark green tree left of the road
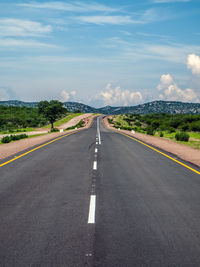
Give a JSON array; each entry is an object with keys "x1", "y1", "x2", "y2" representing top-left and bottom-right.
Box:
[{"x1": 38, "y1": 100, "x2": 67, "y2": 129}]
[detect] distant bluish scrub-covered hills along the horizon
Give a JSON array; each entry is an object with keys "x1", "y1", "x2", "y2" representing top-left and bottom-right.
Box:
[{"x1": 0, "y1": 100, "x2": 200, "y2": 114}]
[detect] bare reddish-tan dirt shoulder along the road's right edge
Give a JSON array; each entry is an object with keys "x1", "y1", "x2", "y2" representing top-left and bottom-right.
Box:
[{"x1": 104, "y1": 117, "x2": 200, "y2": 167}]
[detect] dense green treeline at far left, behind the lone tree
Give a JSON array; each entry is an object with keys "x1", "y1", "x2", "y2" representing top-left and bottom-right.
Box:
[{"x1": 0, "y1": 105, "x2": 65, "y2": 132}]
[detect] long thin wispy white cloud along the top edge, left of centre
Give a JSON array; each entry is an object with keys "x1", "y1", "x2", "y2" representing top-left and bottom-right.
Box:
[{"x1": 18, "y1": 1, "x2": 116, "y2": 12}]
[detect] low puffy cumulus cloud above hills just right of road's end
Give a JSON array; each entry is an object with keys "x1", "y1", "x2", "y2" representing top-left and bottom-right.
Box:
[{"x1": 100, "y1": 83, "x2": 143, "y2": 106}]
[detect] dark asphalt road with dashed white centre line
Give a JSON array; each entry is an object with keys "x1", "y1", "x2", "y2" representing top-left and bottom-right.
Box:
[{"x1": 0, "y1": 119, "x2": 200, "y2": 267}]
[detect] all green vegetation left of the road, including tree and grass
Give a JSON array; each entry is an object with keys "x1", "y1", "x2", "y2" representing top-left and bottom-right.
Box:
[{"x1": 0, "y1": 100, "x2": 83, "y2": 144}]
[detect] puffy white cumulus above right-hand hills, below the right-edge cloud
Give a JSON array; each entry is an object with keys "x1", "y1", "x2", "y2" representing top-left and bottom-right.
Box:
[{"x1": 157, "y1": 74, "x2": 199, "y2": 102}]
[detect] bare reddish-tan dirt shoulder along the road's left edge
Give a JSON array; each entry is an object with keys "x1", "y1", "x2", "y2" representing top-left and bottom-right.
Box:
[{"x1": 0, "y1": 114, "x2": 95, "y2": 160}]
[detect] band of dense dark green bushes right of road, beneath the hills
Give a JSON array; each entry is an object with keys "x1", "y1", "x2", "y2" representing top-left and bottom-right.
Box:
[{"x1": 114, "y1": 113, "x2": 200, "y2": 133}]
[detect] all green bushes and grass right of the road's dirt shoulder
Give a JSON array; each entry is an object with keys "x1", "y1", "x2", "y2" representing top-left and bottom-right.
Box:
[{"x1": 111, "y1": 113, "x2": 200, "y2": 149}]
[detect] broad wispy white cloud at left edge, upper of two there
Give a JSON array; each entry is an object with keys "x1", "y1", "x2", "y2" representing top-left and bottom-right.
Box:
[{"x1": 0, "y1": 18, "x2": 52, "y2": 37}]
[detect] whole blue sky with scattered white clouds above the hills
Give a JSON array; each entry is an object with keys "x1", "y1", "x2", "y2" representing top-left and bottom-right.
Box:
[{"x1": 0, "y1": 0, "x2": 200, "y2": 107}]
